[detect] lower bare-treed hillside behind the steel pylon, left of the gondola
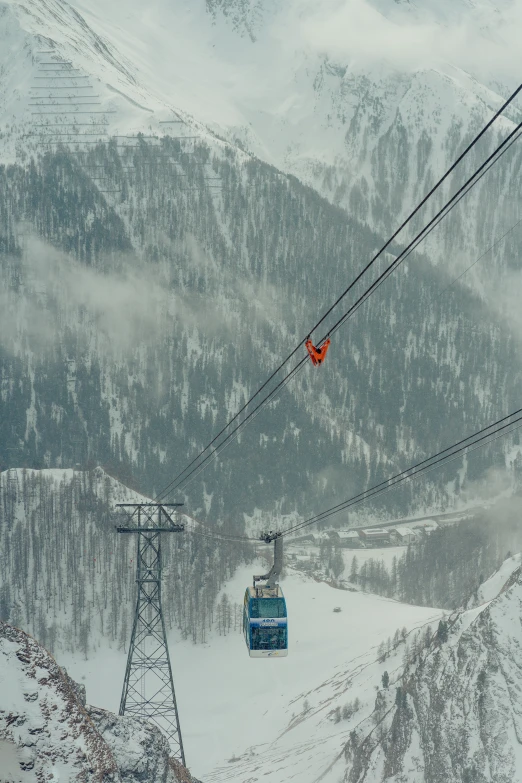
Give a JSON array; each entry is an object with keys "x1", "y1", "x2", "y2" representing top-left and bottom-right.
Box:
[{"x1": 0, "y1": 468, "x2": 251, "y2": 656}]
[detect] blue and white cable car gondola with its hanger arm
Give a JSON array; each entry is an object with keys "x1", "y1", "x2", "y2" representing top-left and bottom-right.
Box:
[{"x1": 243, "y1": 534, "x2": 288, "y2": 658}]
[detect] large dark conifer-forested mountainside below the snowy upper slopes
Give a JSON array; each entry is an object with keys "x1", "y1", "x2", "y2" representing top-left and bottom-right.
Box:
[{"x1": 0, "y1": 138, "x2": 520, "y2": 528}]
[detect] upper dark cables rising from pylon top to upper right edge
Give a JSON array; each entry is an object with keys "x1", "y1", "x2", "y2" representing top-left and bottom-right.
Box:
[{"x1": 154, "y1": 84, "x2": 522, "y2": 498}]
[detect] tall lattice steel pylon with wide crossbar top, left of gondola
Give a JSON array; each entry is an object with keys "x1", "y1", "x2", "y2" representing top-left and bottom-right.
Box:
[{"x1": 116, "y1": 503, "x2": 185, "y2": 765}]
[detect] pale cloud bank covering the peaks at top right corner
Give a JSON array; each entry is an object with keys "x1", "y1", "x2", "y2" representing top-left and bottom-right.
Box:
[{"x1": 274, "y1": 0, "x2": 522, "y2": 81}]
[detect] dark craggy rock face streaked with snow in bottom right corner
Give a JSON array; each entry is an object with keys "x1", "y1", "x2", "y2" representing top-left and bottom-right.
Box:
[{"x1": 345, "y1": 569, "x2": 522, "y2": 783}]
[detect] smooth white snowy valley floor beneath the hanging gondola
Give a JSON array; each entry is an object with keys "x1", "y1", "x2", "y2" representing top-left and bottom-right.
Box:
[{"x1": 61, "y1": 566, "x2": 442, "y2": 783}]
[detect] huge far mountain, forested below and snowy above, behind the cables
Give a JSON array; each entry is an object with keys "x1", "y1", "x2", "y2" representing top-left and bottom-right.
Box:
[{"x1": 0, "y1": 0, "x2": 521, "y2": 528}]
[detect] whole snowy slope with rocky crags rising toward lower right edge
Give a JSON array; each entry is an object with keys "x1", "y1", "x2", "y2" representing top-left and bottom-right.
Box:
[{"x1": 206, "y1": 557, "x2": 522, "y2": 783}]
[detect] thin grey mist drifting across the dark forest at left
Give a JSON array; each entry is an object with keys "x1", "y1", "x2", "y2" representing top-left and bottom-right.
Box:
[{"x1": 0, "y1": 231, "x2": 284, "y2": 354}]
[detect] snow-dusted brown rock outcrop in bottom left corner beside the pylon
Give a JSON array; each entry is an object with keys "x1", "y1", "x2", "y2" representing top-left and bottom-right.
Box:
[{"x1": 0, "y1": 622, "x2": 197, "y2": 783}]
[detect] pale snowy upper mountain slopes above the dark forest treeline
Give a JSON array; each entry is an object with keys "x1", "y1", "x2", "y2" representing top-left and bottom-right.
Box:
[{"x1": 4, "y1": 0, "x2": 521, "y2": 236}]
